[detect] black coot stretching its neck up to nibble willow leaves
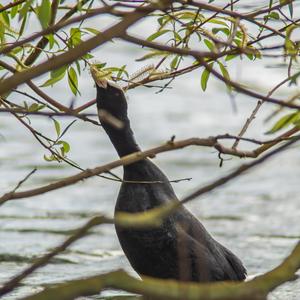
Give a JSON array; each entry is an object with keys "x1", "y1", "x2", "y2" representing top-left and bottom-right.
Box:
[{"x1": 92, "y1": 74, "x2": 246, "y2": 282}]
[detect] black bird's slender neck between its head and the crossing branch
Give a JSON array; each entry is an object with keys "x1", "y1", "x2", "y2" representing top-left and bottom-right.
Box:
[{"x1": 102, "y1": 118, "x2": 141, "y2": 157}]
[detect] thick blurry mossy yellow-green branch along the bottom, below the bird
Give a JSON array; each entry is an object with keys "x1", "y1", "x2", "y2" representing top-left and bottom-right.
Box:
[{"x1": 23, "y1": 243, "x2": 300, "y2": 300}]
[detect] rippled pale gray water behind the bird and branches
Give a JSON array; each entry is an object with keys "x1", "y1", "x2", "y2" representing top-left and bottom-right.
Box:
[{"x1": 0, "y1": 1, "x2": 300, "y2": 300}]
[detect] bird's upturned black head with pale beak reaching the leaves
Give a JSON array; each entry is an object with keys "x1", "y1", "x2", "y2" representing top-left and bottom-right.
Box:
[{"x1": 91, "y1": 66, "x2": 127, "y2": 122}]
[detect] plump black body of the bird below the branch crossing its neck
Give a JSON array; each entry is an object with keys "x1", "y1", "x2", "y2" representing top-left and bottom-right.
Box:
[{"x1": 115, "y1": 160, "x2": 246, "y2": 282}]
